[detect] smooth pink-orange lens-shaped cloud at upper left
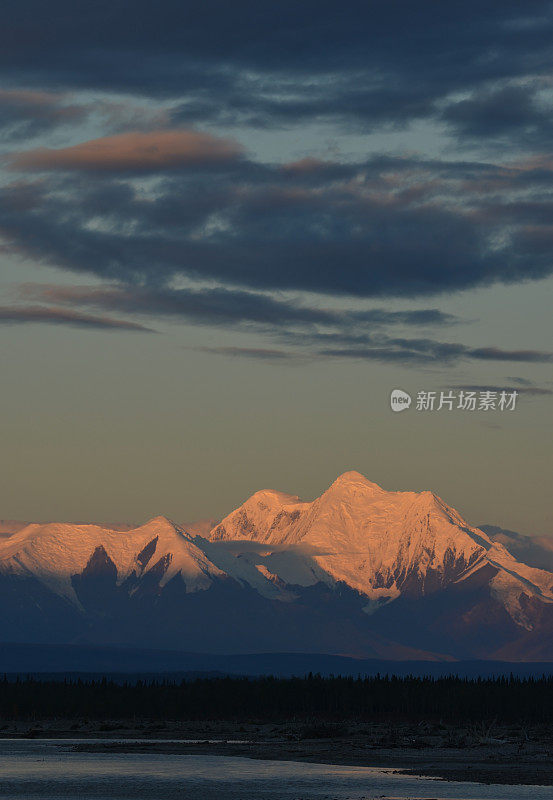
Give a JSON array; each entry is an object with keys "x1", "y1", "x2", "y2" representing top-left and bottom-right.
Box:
[{"x1": 10, "y1": 130, "x2": 243, "y2": 172}]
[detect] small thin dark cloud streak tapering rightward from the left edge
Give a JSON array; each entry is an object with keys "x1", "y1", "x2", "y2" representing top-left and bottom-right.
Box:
[{"x1": 0, "y1": 306, "x2": 153, "y2": 333}]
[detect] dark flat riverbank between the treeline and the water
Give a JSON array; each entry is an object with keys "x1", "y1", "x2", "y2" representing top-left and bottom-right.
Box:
[{"x1": 0, "y1": 720, "x2": 553, "y2": 786}]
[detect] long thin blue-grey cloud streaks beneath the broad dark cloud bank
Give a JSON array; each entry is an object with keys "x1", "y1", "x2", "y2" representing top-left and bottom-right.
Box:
[{"x1": 20, "y1": 284, "x2": 553, "y2": 366}]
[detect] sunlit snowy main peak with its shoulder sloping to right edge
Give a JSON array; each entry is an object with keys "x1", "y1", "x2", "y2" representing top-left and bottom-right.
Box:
[{"x1": 205, "y1": 472, "x2": 553, "y2": 627}]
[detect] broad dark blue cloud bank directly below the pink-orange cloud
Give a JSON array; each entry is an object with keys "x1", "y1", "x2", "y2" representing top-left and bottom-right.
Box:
[{"x1": 0, "y1": 152, "x2": 553, "y2": 298}]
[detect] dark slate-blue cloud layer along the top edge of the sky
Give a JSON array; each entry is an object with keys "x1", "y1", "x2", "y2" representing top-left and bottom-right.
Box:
[{"x1": 0, "y1": 0, "x2": 553, "y2": 135}]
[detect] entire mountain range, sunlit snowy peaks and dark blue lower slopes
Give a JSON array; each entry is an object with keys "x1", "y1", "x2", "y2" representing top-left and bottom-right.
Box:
[{"x1": 0, "y1": 472, "x2": 553, "y2": 661}]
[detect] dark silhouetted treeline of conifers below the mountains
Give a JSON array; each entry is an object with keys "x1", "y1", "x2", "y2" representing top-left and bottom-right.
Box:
[{"x1": 0, "y1": 675, "x2": 553, "y2": 723}]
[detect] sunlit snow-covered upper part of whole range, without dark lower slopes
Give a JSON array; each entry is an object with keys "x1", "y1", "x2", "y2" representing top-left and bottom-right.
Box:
[{"x1": 0, "y1": 472, "x2": 553, "y2": 630}]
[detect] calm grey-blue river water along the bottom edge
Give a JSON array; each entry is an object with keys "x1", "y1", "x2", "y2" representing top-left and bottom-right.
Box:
[{"x1": 0, "y1": 739, "x2": 553, "y2": 800}]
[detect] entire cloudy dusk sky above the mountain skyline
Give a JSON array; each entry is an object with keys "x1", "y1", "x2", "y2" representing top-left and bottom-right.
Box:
[{"x1": 0, "y1": 0, "x2": 553, "y2": 535}]
